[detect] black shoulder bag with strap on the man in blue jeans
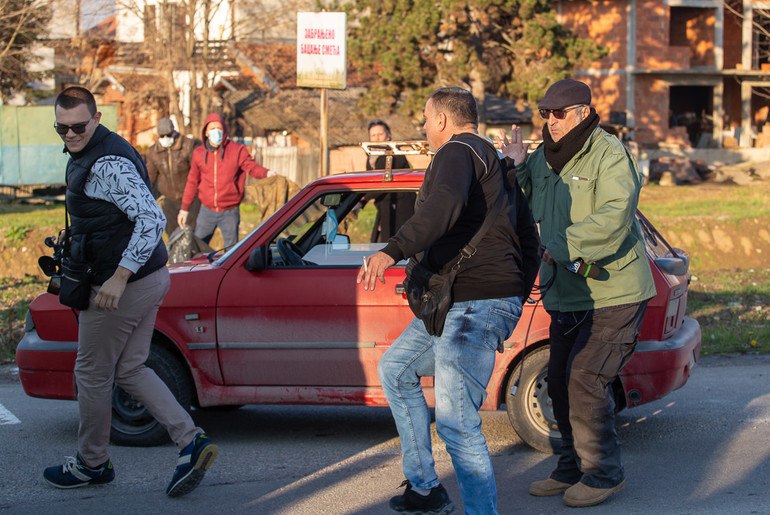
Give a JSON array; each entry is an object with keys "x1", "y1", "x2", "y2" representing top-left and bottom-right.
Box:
[{"x1": 404, "y1": 189, "x2": 507, "y2": 336}]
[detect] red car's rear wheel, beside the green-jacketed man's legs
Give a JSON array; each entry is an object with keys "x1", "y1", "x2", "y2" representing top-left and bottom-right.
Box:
[{"x1": 505, "y1": 347, "x2": 561, "y2": 454}]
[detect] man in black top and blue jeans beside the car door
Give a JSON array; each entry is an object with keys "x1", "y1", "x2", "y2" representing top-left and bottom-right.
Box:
[{"x1": 358, "y1": 88, "x2": 539, "y2": 514}]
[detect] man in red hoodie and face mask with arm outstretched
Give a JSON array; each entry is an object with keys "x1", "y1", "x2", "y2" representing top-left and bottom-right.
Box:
[{"x1": 177, "y1": 113, "x2": 275, "y2": 249}]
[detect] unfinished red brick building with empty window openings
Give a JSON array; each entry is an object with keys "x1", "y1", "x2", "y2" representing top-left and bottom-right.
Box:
[{"x1": 554, "y1": 0, "x2": 770, "y2": 148}]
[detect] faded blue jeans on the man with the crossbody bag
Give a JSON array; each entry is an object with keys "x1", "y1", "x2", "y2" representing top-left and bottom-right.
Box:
[{"x1": 377, "y1": 297, "x2": 522, "y2": 514}]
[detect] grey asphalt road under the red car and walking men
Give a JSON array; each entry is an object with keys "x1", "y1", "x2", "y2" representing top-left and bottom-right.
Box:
[{"x1": 0, "y1": 356, "x2": 770, "y2": 515}]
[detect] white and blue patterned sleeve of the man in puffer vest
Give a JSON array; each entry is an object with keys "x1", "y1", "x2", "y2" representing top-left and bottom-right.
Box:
[{"x1": 83, "y1": 156, "x2": 166, "y2": 273}]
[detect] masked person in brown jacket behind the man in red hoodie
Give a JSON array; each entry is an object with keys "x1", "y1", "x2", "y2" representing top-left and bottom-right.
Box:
[{"x1": 147, "y1": 118, "x2": 201, "y2": 236}]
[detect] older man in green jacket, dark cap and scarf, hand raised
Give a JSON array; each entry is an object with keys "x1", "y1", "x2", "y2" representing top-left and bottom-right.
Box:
[{"x1": 500, "y1": 79, "x2": 655, "y2": 507}]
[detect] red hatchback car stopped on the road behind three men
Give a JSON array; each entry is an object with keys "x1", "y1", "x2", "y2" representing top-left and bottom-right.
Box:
[{"x1": 16, "y1": 151, "x2": 701, "y2": 452}]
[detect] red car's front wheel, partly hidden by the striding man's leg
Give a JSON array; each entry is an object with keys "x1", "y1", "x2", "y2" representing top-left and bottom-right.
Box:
[{"x1": 110, "y1": 345, "x2": 192, "y2": 447}]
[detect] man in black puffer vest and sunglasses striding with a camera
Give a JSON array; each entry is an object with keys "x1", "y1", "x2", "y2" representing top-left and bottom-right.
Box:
[{"x1": 43, "y1": 86, "x2": 217, "y2": 497}]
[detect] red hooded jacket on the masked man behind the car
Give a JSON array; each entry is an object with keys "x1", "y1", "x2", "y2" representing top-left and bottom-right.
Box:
[{"x1": 181, "y1": 113, "x2": 267, "y2": 212}]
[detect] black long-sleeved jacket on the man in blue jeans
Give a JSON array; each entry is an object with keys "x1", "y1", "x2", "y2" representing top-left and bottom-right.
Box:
[{"x1": 383, "y1": 133, "x2": 540, "y2": 302}]
